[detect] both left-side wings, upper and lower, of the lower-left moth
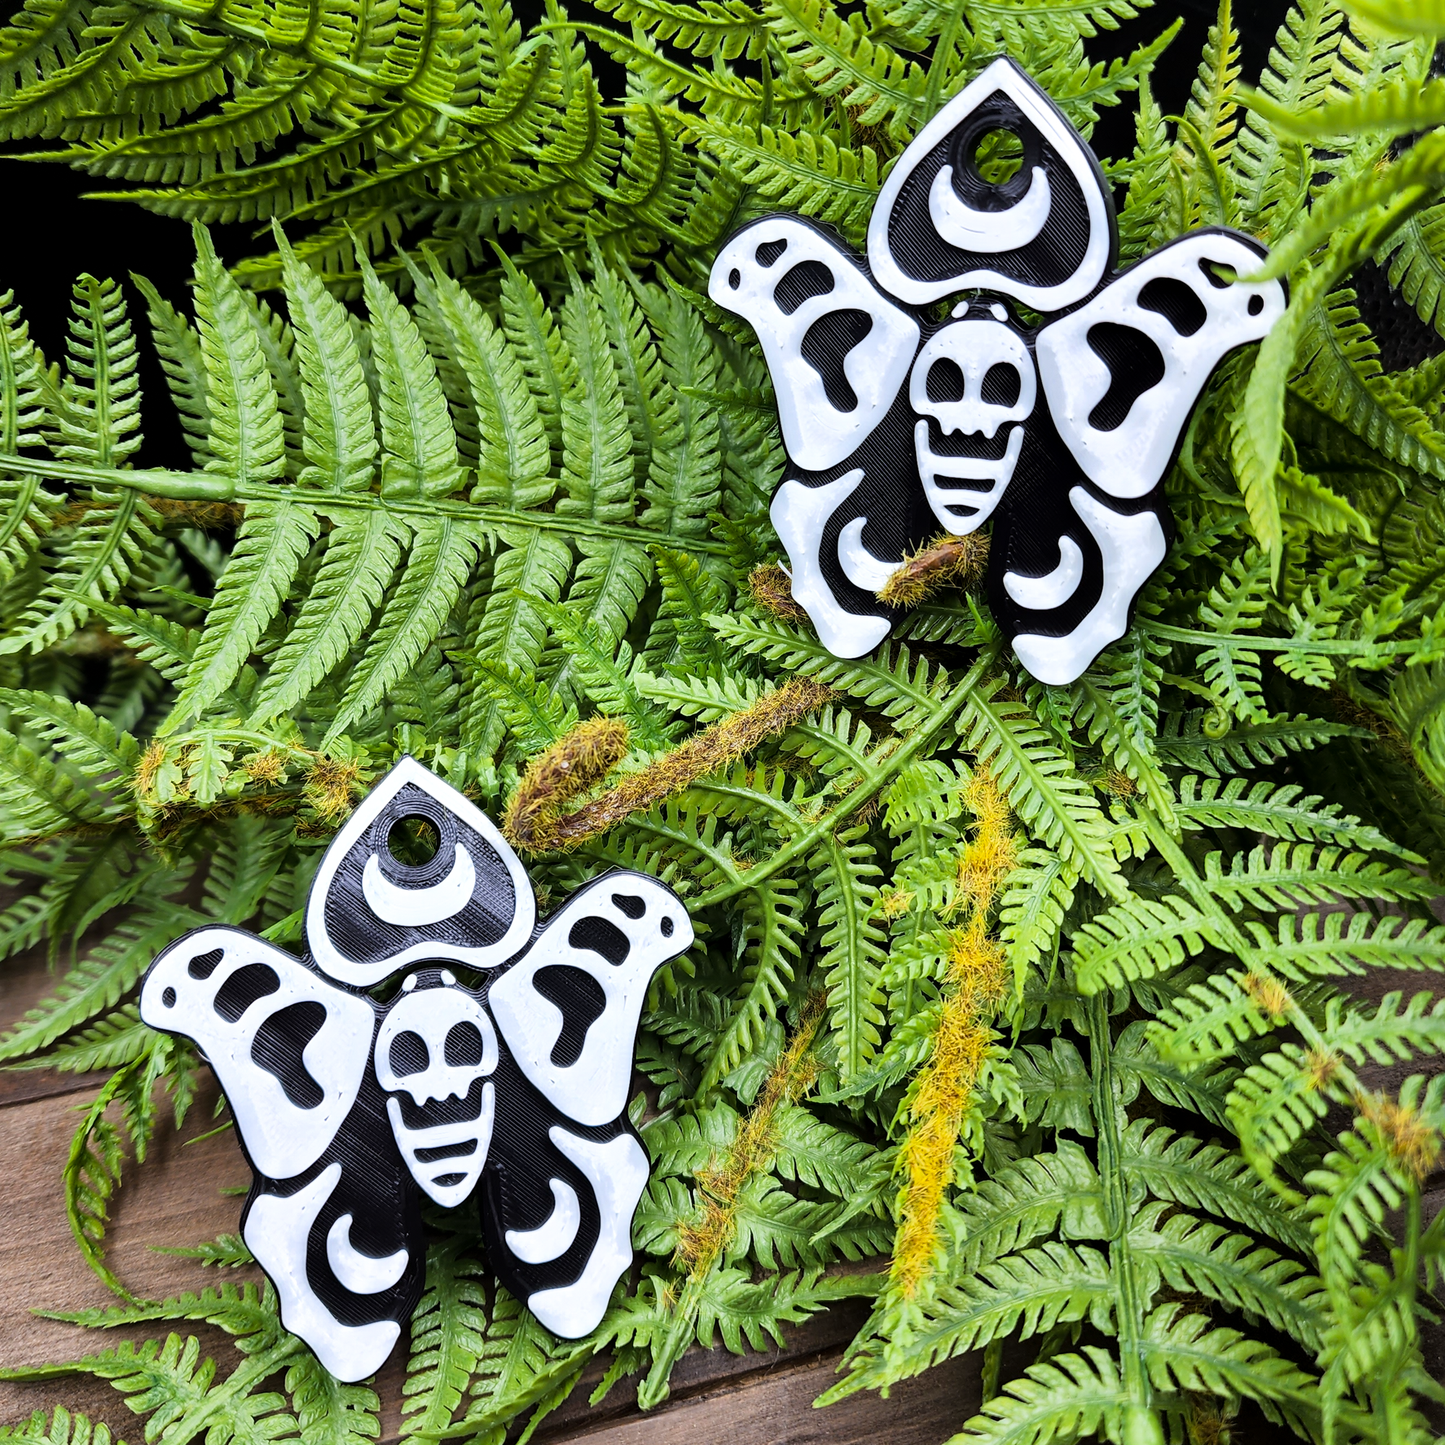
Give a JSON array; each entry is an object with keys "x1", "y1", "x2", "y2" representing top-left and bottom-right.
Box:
[{"x1": 140, "y1": 928, "x2": 425, "y2": 1380}]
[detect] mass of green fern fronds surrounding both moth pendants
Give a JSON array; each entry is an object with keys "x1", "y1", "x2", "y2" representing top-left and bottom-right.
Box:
[{"x1": 0, "y1": 0, "x2": 1445, "y2": 1445}]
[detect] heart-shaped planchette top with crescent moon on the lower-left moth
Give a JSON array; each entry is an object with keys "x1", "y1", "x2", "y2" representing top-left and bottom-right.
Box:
[{"x1": 306, "y1": 757, "x2": 536, "y2": 988}]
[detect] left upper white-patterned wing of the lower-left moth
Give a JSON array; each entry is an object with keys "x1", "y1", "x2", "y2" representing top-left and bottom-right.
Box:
[{"x1": 140, "y1": 928, "x2": 376, "y2": 1179}]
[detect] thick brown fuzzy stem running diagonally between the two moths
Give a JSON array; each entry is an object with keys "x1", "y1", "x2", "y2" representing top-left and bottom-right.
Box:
[{"x1": 501, "y1": 678, "x2": 834, "y2": 853}]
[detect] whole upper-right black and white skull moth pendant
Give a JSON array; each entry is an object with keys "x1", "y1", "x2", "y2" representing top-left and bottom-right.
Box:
[{"x1": 708, "y1": 58, "x2": 1286, "y2": 683}]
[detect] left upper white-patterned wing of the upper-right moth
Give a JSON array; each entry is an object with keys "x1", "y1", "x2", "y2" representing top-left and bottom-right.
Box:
[{"x1": 708, "y1": 215, "x2": 919, "y2": 473}]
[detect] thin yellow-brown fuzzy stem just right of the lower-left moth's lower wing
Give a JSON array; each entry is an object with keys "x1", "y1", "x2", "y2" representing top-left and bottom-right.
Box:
[{"x1": 675, "y1": 993, "x2": 827, "y2": 1279}]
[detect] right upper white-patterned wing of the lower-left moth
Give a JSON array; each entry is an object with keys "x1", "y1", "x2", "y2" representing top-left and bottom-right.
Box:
[{"x1": 487, "y1": 871, "x2": 692, "y2": 1126}]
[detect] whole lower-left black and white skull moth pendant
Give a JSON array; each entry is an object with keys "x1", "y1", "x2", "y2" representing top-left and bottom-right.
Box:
[{"x1": 140, "y1": 757, "x2": 692, "y2": 1381}]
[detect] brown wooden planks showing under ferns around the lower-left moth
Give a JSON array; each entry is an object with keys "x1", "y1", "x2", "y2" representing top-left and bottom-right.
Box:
[{"x1": 0, "y1": 959, "x2": 978, "y2": 1445}]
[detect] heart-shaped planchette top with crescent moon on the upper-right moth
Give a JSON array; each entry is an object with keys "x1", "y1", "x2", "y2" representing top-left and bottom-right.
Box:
[{"x1": 868, "y1": 58, "x2": 1117, "y2": 311}]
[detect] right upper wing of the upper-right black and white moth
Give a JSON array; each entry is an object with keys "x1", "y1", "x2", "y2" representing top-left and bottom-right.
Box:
[{"x1": 1035, "y1": 230, "x2": 1286, "y2": 499}]
